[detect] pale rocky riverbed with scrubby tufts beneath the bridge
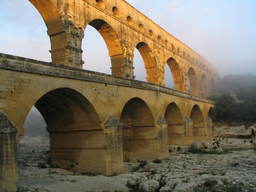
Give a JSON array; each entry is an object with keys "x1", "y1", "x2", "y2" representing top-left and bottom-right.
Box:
[{"x1": 18, "y1": 139, "x2": 256, "y2": 192}]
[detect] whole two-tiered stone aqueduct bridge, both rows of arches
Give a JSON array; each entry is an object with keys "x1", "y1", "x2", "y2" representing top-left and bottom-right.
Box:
[{"x1": 0, "y1": 0, "x2": 217, "y2": 191}]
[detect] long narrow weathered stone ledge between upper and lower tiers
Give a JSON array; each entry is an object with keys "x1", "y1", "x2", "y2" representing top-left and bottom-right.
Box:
[{"x1": 0, "y1": 53, "x2": 214, "y2": 104}]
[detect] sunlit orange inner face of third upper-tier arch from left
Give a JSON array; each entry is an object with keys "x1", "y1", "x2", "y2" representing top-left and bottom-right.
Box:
[{"x1": 136, "y1": 42, "x2": 159, "y2": 84}]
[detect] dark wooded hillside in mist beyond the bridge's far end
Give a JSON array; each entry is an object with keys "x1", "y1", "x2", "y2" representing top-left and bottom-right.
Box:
[{"x1": 211, "y1": 75, "x2": 256, "y2": 124}]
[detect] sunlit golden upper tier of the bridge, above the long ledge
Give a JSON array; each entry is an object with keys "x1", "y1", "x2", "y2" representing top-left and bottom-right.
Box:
[{"x1": 27, "y1": 0, "x2": 218, "y2": 96}]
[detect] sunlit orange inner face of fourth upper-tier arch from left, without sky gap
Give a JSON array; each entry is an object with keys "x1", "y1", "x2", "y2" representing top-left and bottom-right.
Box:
[{"x1": 167, "y1": 57, "x2": 185, "y2": 91}]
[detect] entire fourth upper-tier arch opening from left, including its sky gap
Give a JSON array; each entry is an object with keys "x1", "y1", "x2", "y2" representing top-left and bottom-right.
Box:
[{"x1": 165, "y1": 58, "x2": 185, "y2": 91}]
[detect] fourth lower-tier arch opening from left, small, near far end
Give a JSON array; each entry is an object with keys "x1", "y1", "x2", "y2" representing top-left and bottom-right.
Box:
[{"x1": 190, "y1": 105, "x2": 206, "y2": 136}]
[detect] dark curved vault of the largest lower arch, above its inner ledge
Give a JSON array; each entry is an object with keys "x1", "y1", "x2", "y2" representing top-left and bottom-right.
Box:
[{"x1": 35, "y1": 88, "x2": 101, "y2": 132}]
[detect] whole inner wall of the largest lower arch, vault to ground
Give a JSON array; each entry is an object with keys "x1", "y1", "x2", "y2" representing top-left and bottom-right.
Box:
[{"x1": 19, "y1": 88, "x2": 105, "y2": 173}]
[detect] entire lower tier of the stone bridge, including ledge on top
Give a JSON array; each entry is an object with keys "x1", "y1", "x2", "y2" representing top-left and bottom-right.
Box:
[{"x1": 0, "y1": 54, "x2": 214, "y2": 189}]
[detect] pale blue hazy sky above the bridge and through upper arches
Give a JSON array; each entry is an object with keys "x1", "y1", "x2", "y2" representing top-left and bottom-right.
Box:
[{"x1": 0, "y1": 0, "x2": 256, "y2": 81}]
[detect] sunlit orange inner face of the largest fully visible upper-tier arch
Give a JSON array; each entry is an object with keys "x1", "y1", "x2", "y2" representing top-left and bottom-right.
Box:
[{"x1": 85, "y1": 19, "x2": 126, "y2": 77}]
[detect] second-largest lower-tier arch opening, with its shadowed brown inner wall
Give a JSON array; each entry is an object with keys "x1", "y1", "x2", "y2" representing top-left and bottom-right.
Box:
[{"x1": 120, "y1": 98, "x2": 157, "y2": 162}]
